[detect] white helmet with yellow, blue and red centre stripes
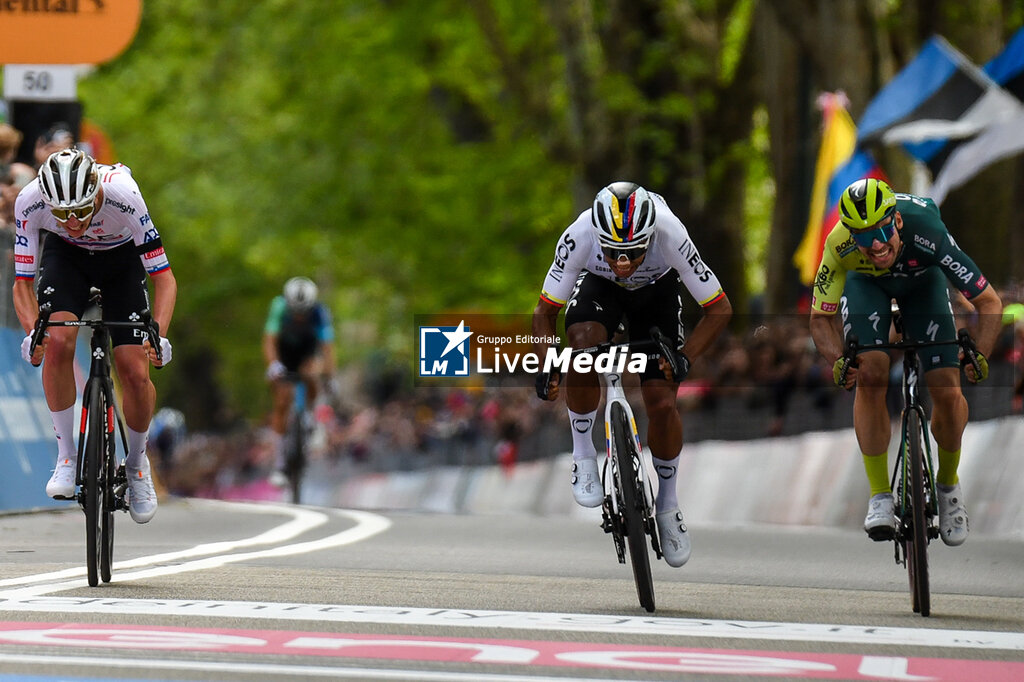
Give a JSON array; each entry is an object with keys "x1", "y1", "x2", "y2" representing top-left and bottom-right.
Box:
[{"x1": 591, "y1": 182, "x2": 654, "y2": 249}]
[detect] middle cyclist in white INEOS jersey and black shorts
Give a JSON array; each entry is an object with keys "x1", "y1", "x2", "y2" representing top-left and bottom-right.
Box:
[{"x1": 532, "y1": 182, "x2": 732, "y2": 566}]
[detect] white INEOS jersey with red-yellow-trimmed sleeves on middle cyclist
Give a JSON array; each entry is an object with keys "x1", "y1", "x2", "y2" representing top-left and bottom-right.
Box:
[{"x1": 541, "y1": 193, "x2": 723, "y2": 306}]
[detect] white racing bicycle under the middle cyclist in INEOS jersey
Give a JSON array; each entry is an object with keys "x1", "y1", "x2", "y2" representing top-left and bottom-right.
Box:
[{"x1": 572, "y1": 327, "x2": 680, "y2": 612}]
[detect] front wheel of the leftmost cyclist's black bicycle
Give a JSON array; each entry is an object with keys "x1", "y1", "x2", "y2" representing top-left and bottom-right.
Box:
[{"x1": 82, "y1": 381, "x2": 106, "y2": 587}]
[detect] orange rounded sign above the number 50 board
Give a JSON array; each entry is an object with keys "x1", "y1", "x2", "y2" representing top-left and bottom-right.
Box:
[{"x1": 0, "y1": 0, "x2": 142, "y2": 65}]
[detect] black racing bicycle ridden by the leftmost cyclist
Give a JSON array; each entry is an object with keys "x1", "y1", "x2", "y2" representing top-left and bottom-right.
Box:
[{"x1": 30, "y1": 288, "x2": 160, "y2": 587}]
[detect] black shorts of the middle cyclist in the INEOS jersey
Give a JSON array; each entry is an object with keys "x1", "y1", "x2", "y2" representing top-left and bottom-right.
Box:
[{"x1": 565, "y1": 270, "x2": 686, "y2": 383}]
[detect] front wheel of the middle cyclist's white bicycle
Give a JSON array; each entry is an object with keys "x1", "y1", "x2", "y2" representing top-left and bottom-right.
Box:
[{"x1": 611, "y1": 402, "x2": 654, "y2": 612}]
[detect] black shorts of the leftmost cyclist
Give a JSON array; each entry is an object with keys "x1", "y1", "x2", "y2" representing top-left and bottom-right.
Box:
[{"x1": 36, "y1": 235, "x2": 150, "y2": 346}]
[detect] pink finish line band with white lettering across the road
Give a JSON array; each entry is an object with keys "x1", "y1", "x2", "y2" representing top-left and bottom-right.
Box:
[{"x1": 0, "y1": 623, "x2": 1024, "y2": 682}]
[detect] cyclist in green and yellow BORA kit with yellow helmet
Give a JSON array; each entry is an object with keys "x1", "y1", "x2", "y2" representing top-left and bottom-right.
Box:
[{"x1": 810, "y1": 178, "x2": 1002, "y2": 546}]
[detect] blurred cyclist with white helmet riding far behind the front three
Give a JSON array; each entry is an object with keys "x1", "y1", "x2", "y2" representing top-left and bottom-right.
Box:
[{"x1": 263, "y1": 276, "x2": 335, "y2": 465}]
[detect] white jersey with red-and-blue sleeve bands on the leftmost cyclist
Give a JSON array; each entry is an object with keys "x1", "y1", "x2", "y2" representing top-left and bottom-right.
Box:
[{"x1": 14, "y1": 164, "x2": 170, "y2": 280}]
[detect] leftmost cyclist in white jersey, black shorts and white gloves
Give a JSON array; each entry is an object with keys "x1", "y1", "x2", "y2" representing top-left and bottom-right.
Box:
[{"x1": 13, "y1": 148, "x2": 177, "y2": 523}]
